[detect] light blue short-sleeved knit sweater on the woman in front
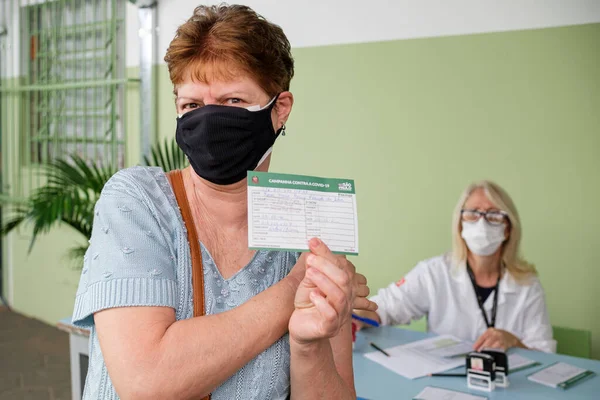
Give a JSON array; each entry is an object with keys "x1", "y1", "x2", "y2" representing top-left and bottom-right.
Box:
[{"x1": 73, "y1": 167, "x2": 298, "y2": 400}]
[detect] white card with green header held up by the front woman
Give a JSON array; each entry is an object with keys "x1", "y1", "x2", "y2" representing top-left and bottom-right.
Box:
[{"x1": 248, "y1": 171, "x2": 358, "y2": 255}]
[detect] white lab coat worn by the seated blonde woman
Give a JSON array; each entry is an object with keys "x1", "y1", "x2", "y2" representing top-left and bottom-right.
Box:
[{"x1": 371, "y1": 254, "x2": 556, "y2": 352}]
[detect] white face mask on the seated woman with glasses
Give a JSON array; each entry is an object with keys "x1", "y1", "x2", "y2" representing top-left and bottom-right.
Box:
[{"x1": 460, "y1": 217, "x2": 506, "y2": 256}]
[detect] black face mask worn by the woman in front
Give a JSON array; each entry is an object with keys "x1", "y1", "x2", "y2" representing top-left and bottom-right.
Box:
[{"x1": 175, "y1": 98, "x2": 281, "y2": 185}]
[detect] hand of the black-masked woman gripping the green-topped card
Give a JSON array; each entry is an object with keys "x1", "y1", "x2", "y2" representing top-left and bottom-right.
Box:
[{"x1": 289, "y1": 239, "x2": 376, "y2": 344}]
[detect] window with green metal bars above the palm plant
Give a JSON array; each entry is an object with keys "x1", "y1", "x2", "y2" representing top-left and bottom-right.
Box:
[{"x1": 0, "y1": 0, "x2": 127, "y2": 195}]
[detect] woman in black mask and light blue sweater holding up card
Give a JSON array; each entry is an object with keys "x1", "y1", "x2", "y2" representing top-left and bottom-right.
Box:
[{"x1": 73, "y1": 6, "x2": 376, "y2": 400}]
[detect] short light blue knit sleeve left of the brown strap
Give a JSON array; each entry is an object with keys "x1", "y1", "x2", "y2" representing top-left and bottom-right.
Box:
[{"x1": 73, "y1": 170, "x2": 177, "y2": 328}]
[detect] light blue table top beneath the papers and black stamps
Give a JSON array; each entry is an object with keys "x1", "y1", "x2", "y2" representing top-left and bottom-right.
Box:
[{"x1": 353, "y1": 326, "x2": 600, "y2": 400}]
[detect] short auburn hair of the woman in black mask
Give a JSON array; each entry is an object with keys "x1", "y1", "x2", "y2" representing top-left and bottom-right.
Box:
[{"x1": 165, "y1": 4, "x2": 294, "y2": 96}]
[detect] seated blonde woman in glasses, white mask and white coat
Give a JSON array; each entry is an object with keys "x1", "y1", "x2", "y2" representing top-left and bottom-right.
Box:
[{"x1": 359, "y1": 181, "x2": 556, "y2": 352}]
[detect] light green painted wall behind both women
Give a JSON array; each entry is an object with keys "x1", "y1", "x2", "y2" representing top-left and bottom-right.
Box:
[{"x1": 5, "y1": 24, "x2": 600, "y2": 359}]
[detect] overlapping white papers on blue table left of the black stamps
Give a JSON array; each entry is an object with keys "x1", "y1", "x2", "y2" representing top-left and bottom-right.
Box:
[{"x1": 365, "y1": 335, "x2": 465, "y2": 379}]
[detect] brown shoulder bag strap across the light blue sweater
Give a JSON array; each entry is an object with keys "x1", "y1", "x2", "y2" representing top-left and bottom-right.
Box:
[{"x1": 167, "y1": 169, "x2": 210, "y2": 400}]
